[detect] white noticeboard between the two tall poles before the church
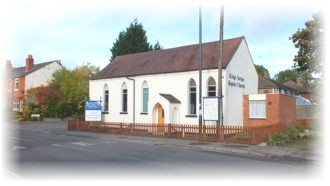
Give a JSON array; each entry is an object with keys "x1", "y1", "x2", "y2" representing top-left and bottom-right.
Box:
[{"x1": 203, "y1": 96, "x2": 219, "y2": 121}]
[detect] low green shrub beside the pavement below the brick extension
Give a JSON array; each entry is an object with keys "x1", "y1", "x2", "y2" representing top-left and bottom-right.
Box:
[{"x1": 267, "y1": 125, "x2": 309, "y2": 145}]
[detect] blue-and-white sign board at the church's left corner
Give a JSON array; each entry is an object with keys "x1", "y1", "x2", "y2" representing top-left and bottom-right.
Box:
[{"x1": 85, "y1": 101, "x2": 102, "y2": 121}]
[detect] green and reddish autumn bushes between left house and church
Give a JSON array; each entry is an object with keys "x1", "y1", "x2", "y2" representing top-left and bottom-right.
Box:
[{"x1": 20, "y1": 63, "x2": 99, "y2": 120}]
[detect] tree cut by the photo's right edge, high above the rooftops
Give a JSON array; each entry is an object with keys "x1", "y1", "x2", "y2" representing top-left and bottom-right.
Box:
[{"x1": 289, "y1": 12, "x2": 324, "y2": 77}]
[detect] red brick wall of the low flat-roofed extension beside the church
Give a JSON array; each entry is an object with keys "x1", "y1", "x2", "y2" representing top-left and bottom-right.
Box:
[{"x1": 243, "y1": 94, "x2": 296, "y2": 126}]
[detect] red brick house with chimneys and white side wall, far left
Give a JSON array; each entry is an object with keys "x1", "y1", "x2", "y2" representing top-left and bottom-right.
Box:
[{"x1": 3, "y1": 55, "x2": 62, "y2": 112}]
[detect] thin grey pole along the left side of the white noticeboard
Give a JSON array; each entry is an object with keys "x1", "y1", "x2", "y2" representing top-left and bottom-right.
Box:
[{"x1": 198, "y1": 5, "x2": 203, "y2": 134}]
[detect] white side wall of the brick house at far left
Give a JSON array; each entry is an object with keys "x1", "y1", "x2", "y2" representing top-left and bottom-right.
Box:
[{"x1": 25, "y1": 62, "x2": 62, "y2": 92}]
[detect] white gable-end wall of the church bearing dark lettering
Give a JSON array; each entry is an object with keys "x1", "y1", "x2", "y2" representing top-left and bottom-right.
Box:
[{"x1": 223, "y1": 40, "x2": 258, "y2": 125}]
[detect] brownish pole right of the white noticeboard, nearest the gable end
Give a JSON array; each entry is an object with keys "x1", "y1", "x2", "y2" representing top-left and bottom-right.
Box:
[{"x1": 218, "y1": 5, "x2": 224, "y2": 126}]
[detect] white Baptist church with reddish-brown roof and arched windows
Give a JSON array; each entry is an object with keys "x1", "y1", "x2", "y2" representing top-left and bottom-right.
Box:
[{"x1": 89, "y1": 37, "x2": 258, "y2": 126}]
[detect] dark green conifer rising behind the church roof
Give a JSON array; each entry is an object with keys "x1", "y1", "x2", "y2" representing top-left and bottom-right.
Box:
[{"x1": 110, "y1": 19, "x2": 162, "y2": 60}]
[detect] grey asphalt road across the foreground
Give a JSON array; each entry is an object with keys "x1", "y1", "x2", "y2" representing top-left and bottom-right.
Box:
[{"x1": 5, "y1": 123, "x2": 315, "y2": 179}]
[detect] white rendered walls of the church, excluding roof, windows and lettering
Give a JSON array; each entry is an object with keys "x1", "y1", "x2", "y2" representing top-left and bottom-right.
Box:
[{"x1": 89, "y1": 40, "x2": 258, "y2": 125}]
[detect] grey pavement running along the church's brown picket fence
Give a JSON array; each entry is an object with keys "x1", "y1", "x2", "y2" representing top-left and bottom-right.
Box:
[{"x1": 8, "y1": 121, "x2": 323, "y2": 163}]
